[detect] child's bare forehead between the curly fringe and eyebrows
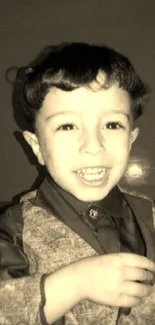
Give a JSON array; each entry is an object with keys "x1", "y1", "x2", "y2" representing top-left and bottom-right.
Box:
[{"x1": 41, "y1": 83, "x2": 131, "y2": 119}]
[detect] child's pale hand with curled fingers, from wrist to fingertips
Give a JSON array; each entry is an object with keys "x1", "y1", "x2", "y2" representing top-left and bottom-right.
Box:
[{"x1": 81, "y1": 253, "x2": 155, "y2": 307}]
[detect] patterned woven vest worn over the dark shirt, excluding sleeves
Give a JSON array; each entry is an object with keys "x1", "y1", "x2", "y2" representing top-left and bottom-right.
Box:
[{"x1": 21, "y1": 190, "x2": 155, "y2": 325}]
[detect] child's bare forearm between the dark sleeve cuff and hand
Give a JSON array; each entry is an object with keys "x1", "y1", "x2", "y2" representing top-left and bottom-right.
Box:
[{"x1": 44, "y1": 261, "x2": 85, "y2": 324}]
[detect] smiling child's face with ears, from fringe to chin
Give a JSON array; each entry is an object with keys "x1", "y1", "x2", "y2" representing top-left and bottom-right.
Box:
[{"x1": 24, "y1": 77, "x2": 139, "y2": 201}]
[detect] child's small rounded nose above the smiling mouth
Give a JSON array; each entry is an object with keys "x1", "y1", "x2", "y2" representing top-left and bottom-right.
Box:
[{"x1": 80, "y1": 132, "x2": 104, "y2": 156}]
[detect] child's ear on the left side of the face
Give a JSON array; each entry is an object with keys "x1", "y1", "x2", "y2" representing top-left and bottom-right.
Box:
[{"x1": 23, "y1": 131, "x2": 45, "y2": 165}]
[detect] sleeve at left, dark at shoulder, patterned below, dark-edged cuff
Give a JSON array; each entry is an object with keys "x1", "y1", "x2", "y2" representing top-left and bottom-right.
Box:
[{"x1": 0, "y1": 206, "x2": 48, "y2": 325}]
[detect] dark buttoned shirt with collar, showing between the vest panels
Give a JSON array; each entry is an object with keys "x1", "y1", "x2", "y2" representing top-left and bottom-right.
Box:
[{"x1": 34, "y1": 174, "x2": 146, "y2": 256}]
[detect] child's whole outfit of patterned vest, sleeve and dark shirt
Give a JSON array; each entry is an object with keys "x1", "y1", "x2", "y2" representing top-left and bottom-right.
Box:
[{"x1": 0, "y1": 175, "x2": 155, "y2": 325}]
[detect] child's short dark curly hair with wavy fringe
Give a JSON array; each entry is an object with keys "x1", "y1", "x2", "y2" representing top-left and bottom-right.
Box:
[{"x1": 12, "y1": 42, "x2": 148, "y2": 132}]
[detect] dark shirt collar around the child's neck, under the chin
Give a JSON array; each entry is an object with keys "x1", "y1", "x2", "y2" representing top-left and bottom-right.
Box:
[{"x1": 36, "y1": 174, "x2": 124, "y2": 218}]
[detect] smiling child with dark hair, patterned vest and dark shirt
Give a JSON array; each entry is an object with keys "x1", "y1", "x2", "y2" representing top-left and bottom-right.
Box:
[{"x1": 0, "y1": 43, "x2": 155, "y2": 325}]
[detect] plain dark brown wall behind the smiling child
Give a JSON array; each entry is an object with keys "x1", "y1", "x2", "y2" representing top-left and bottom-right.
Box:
[{"x1": 0, "y1": 0, "x2": 155, "y2": 206}]
